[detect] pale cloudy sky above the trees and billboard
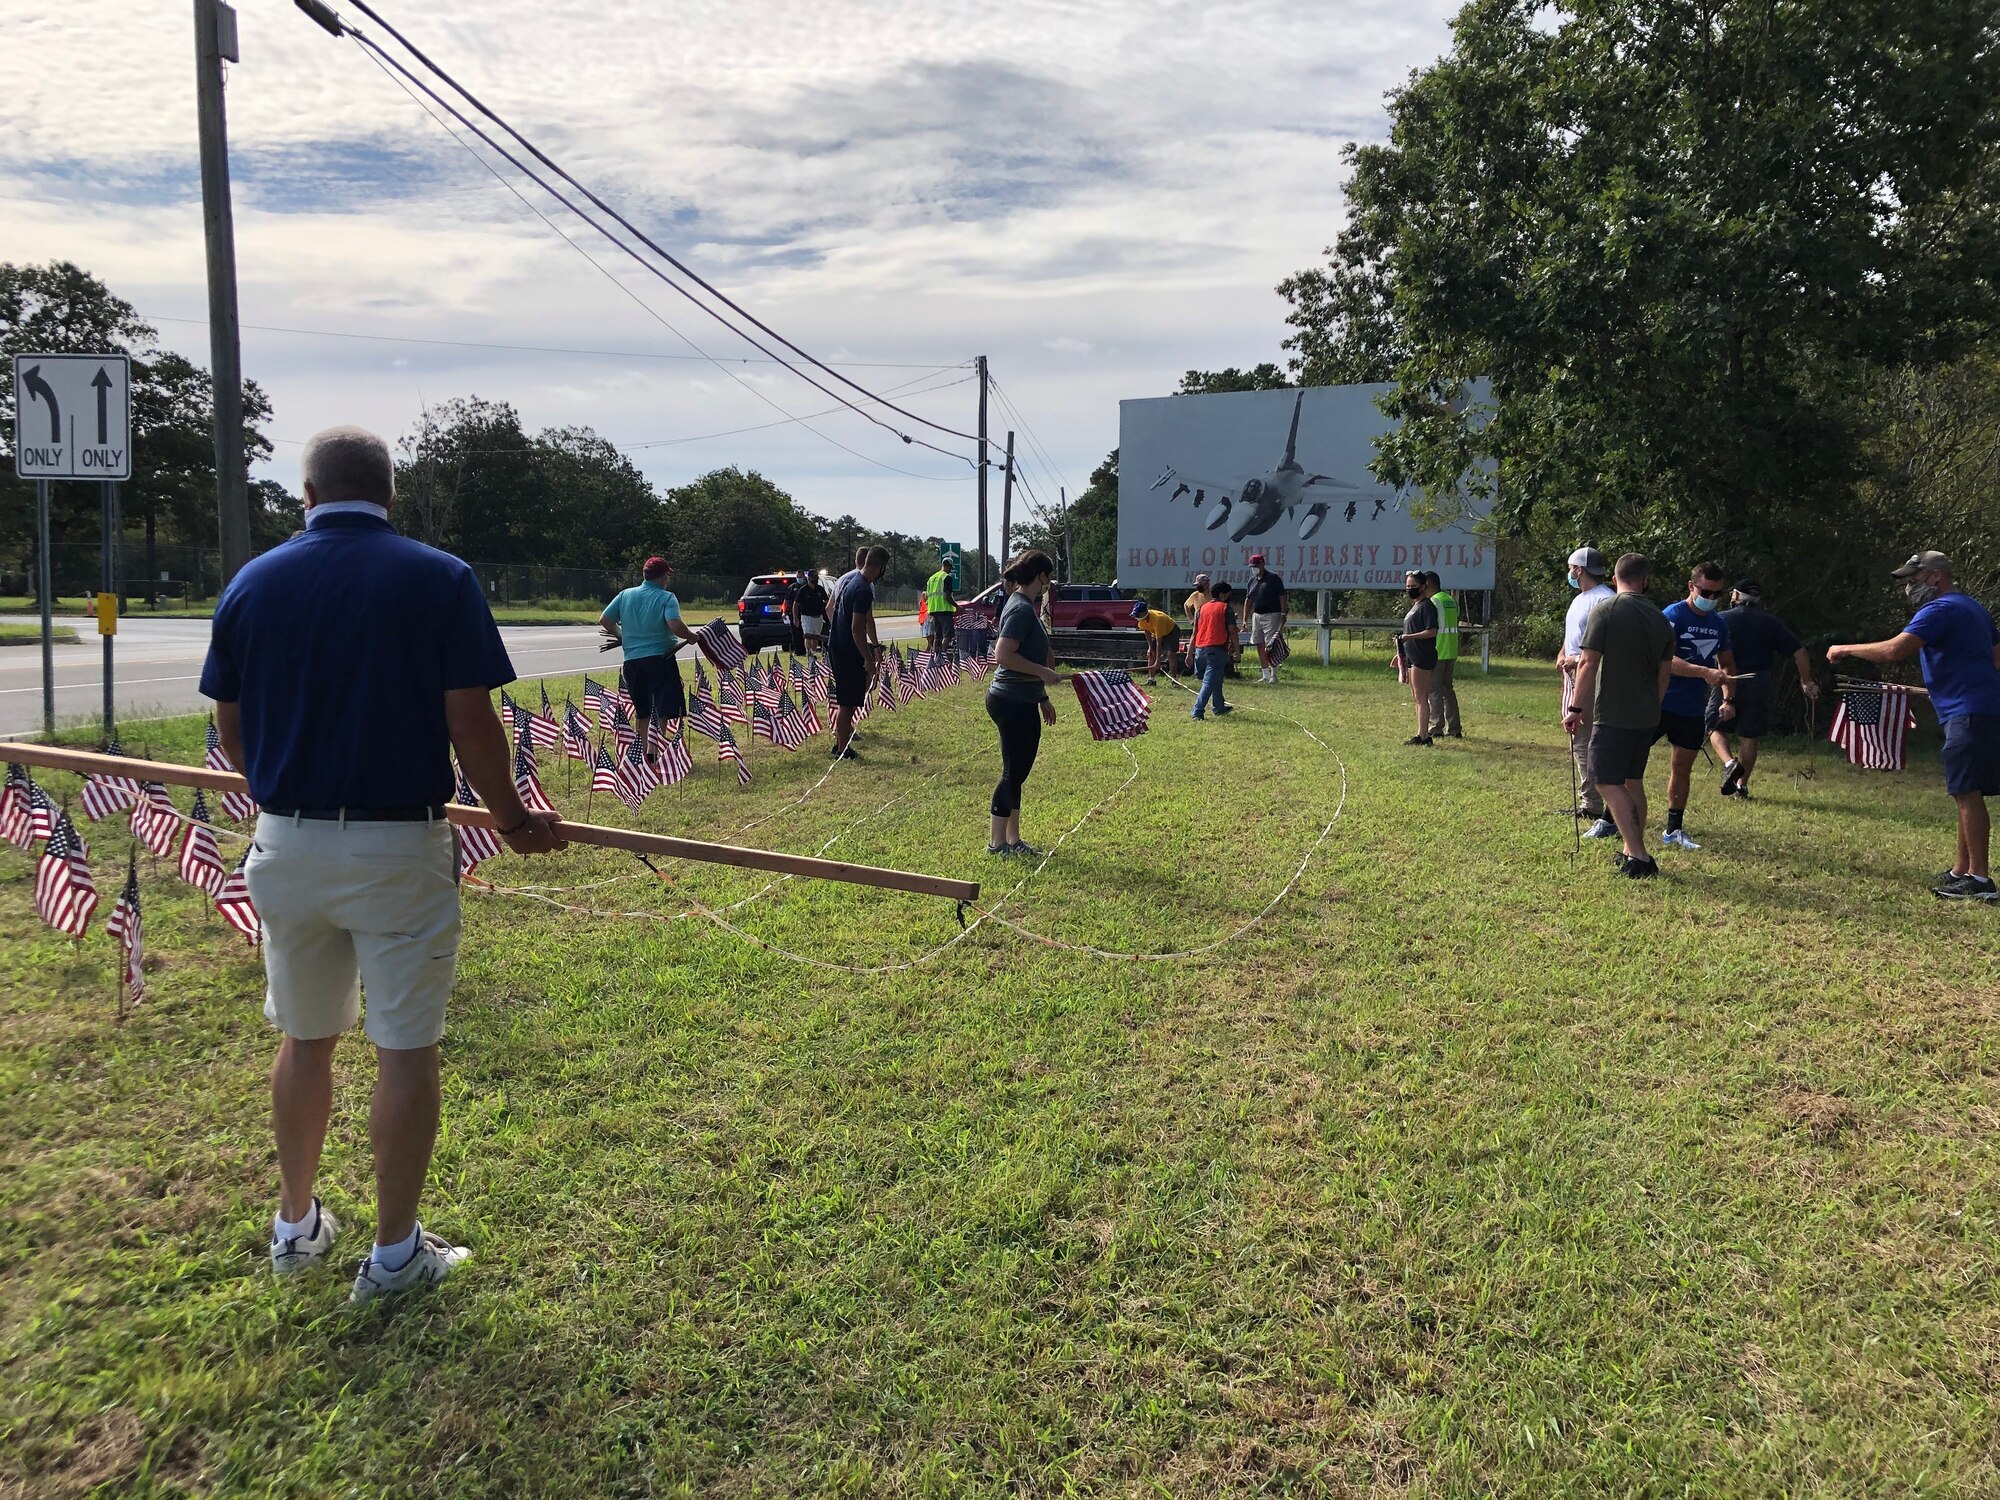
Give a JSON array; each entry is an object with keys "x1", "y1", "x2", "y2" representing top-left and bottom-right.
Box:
[{"x1": 0, "y1": 0, "x2": 1454, "y2": 542}]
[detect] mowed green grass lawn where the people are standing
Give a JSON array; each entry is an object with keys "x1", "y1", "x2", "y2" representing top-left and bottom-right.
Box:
[{"x1": 0, "y1": 656, "x2": 2000, "y2": 1496}]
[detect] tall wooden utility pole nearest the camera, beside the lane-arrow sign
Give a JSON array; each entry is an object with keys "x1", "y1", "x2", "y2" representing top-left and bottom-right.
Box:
[{"x1": 194, "y1": 0, "x2": 250, "y2": 584}]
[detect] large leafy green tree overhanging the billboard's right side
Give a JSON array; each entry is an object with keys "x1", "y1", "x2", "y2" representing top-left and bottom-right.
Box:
[{"x1": 1280, "y1": 0, "x2": 2000, "y2": 640}]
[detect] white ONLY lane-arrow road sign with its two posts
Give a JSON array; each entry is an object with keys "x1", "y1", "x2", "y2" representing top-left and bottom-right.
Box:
[{"x1": 14, "y1": 354, "x2": 132, "y2": 738}]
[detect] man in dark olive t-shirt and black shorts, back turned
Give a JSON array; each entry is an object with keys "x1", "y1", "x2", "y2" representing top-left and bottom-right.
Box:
[{"x1": 1562, "y1": 552, "x2": 1674, "y2": 880}]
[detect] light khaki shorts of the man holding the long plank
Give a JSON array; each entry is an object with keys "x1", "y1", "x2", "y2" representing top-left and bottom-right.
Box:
[{"x1": 244, "y1": 812, "x2": 458, "y2": 1050}]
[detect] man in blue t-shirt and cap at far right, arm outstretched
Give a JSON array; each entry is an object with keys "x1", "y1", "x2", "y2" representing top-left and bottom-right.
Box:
[{"x1": 1826, "y1": 552, "x2": 2000, "y2": 902}]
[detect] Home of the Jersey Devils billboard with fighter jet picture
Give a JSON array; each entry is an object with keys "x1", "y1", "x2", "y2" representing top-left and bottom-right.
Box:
[{"x1": 1118, "y1": 386, "x2": 1494, "y2": 590}]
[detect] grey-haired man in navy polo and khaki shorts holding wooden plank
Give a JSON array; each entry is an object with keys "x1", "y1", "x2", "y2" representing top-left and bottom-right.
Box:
[{"x1": 202, "y1": 428, "x2": 562, "y2": 1302}]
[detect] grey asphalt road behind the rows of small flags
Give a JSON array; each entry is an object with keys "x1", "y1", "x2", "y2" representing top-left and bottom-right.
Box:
[{"x1": 0, "y1": 614, "x2": 920, "y2": 738}]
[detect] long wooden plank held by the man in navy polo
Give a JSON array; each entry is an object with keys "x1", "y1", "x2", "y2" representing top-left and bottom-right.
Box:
[{"x1": 0, "y1": 744, "x2": 980, "y2": 902}]
